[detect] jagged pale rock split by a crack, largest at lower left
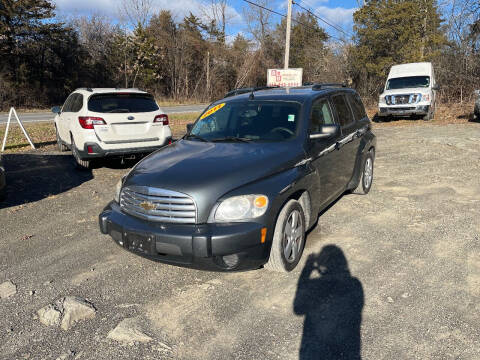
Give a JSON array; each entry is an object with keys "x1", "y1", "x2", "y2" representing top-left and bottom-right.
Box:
[{"x1": 37, "y1": 296, "x2": 96, "y2": 330}]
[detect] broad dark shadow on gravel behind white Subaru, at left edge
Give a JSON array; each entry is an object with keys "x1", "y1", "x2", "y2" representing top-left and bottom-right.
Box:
[{"x1": 0, "y1": 153, "x2": 93, "y2": 209}]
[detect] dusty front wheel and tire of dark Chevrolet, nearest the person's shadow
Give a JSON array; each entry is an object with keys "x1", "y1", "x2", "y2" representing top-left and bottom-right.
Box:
[{"x1": 265, "y1": 200, "x2": 305, "y2": 272}]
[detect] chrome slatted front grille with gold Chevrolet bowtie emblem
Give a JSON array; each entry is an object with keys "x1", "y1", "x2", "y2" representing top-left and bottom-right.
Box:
[{"x1": 120, "y1": 186, "x2": 197, "y2": 224}]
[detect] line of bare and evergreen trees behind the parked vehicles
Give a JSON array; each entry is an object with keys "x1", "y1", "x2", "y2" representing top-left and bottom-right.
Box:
[{"x1": 0, "y1": 0, "x2": 480, "y2": 109}]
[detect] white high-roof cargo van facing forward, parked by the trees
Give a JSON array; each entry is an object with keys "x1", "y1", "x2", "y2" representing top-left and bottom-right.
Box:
[{"x1": 378, "y1": 62, "x2": 439, "y2": 120}]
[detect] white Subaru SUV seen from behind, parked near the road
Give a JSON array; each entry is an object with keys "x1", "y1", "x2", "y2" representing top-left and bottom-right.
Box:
[{"x1": 52, "y1": 88, "x2": 172, "y2": 168}]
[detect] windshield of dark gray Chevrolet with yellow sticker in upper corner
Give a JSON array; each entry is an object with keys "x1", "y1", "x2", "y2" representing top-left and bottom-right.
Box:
[{"x1": 190, "y1": 100, "x2": 301, "y2": 142}]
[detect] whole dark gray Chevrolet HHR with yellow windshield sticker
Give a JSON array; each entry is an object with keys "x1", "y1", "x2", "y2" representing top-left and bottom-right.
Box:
[{"x1": 99, "y1": 84, "x2": 376, "y2": 271}]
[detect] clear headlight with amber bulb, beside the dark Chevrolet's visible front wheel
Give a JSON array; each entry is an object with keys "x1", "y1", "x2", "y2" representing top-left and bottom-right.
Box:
[{"x1": 215, "y1": 195, "x2": 268, "y2": 221}]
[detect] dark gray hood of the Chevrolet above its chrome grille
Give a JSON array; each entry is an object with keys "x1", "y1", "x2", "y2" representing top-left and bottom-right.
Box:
[{"x1": 124, "y1": 140, "x2": 304, "y2": 222}]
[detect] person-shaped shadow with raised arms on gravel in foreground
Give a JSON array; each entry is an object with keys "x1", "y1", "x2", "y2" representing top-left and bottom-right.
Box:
[{"x1": 293, "y1": 245, "x2": 364, "y2": 360}]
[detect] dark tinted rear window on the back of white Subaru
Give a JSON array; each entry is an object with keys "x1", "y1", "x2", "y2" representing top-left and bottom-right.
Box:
[{"x1": 88, "y1": 94, "x2": 158, "y2": 113}]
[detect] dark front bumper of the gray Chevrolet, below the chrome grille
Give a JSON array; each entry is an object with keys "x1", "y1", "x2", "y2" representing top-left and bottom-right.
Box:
[{"x1": 99, "y1": 201, "x2": 270, "y2": 271}]
